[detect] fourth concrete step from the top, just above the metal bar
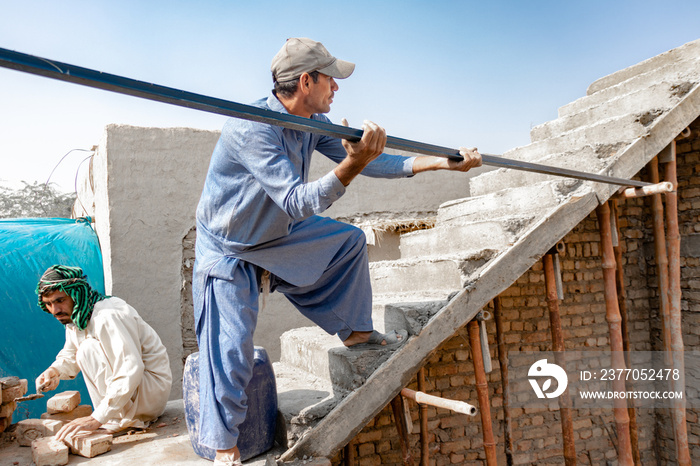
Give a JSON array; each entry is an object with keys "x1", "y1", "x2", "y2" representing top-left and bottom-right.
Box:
[{"x1": 503, "y1": 114, "x2": 658, "y2": 162}]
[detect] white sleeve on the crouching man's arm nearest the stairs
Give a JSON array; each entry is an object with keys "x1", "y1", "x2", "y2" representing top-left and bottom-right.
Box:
[{"x1": 92, "y1": 309, "x2": 144, "y2": 424}]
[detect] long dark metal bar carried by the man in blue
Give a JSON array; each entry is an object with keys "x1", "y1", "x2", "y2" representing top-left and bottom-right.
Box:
[{"x1": 0, "y1": 44, "x2": 649, "y2": 187}]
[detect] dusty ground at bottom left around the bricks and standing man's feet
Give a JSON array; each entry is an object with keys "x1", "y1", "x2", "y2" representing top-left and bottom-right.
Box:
[{"x1": 0, "y1": 400, "x2": 280, "y2": 466}]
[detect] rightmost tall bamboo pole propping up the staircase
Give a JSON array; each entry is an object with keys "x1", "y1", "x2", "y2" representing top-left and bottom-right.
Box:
[{"x1": 665, "y1": 141, "x2": 691, "y2": 466}]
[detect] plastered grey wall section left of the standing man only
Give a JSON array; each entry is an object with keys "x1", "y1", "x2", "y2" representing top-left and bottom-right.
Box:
[{"x1": 93, "y1": 125, "x2": 218, "y2": 398}]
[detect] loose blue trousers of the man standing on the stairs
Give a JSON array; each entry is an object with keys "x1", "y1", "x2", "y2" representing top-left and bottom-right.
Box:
[{"x1": 193, "y1": 217, "x2": 372, "y2": 450}]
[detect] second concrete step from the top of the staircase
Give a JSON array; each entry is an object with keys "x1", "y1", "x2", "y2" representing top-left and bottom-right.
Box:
[{"x1": 558, "y1": 55, "x2": 700, "y2": 117}]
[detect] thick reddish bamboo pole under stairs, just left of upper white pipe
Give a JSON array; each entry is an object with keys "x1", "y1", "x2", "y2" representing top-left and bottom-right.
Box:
[{"x1": 596, "y1": 202, "x2": 634, "y2": 466}]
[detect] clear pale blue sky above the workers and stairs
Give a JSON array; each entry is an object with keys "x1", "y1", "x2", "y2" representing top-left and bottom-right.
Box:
[{"x1": 0, "y1": 0, "x2": 700, "y2": 191}]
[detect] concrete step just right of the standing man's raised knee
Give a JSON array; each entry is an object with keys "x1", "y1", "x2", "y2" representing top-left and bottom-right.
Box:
[{"x1": 400, "y1": 219, "x2": 522, "y2": 259}]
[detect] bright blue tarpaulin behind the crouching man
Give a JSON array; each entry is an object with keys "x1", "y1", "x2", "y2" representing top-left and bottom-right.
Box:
[{"x1": 0, "y1": 218, "x2": 105, "y2": 422}]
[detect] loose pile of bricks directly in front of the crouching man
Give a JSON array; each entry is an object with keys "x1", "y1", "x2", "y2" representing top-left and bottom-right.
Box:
[{"x1": 15, "y1": 391, "x2": 112, "y2": 466}]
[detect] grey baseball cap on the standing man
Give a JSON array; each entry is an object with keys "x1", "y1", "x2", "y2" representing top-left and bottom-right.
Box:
[{"x1": 270, "y1": 37, "x2": 355, "y2": 83}]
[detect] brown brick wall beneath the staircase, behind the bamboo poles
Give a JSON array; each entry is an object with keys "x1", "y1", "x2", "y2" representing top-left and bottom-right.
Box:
[{"x1": 333, "y1": 119, "x2": 700, "y2": 466}]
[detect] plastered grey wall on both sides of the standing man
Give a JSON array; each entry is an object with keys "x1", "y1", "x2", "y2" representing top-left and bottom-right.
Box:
[{"x1": 89, "y1": 125, "x2": 486, "y2": 398}]
